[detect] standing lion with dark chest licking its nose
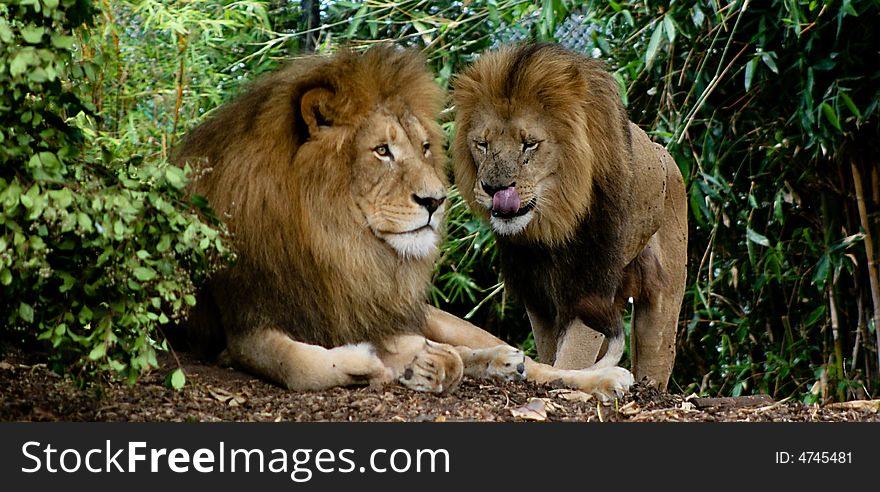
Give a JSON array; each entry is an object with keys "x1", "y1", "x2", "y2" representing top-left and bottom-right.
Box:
[{"x1": 453, "y1": 44, "x2": 687, "y2": 388}]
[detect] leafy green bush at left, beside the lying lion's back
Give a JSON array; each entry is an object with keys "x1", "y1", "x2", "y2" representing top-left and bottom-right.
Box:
[{"x1": 0, "y1": 0, "x2": 230, "y2": 381}]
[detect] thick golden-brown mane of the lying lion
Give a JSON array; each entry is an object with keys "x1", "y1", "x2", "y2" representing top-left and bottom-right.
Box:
[{"x1": 174, "y1": 46, "x2": 443, "y2": 352}]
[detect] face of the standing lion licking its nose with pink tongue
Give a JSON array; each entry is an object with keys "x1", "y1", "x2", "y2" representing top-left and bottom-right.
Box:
[{"x1": 467, "y1": 108, "x2": 560, "y2": 235}]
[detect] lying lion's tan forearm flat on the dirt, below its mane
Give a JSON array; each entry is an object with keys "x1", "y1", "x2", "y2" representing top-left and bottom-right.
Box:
[{"x1": 221, "y1": 329, "x2": 390, "y2": 390}]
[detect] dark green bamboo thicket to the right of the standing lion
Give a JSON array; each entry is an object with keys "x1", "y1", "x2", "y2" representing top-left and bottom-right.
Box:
[{"x1": 593, "y1": 0, "x2": 880, "y2": 401}]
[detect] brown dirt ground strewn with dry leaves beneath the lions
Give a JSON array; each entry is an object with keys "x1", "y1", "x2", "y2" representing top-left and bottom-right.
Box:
[{"x1": 0, "y1": 350, "x2": 880, "y2": 422}]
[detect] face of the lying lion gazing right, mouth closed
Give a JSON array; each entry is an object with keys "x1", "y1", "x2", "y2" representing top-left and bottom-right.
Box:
[{"x1": 351, "y1": 107, "x2": 446, "y2": 258}]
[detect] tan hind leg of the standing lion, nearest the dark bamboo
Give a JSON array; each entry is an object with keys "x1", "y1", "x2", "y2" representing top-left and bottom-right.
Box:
[{"x1": 632, "y1": 153, "x2": 688, "y2": 389}]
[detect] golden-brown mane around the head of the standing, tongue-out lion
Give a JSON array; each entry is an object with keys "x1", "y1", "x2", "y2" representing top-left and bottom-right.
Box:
[{"x1": 453, "y1": 45, "x2": 633, "y2": 245}]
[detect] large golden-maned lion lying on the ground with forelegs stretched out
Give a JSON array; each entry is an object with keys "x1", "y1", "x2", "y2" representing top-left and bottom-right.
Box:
[{"x1": 174, "y1": 46, "x2": 623, "y2": 397}]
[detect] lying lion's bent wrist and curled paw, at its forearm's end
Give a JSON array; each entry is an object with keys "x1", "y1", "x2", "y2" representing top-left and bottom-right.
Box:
[{"x1": 381, "y1": 335, "x2": 464, "y2": 393}]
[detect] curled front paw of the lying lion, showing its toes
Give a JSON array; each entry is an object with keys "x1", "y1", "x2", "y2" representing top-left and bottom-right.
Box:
[{"x1": 397, "y1": 340, "x2": 464, "y2": 393}]
